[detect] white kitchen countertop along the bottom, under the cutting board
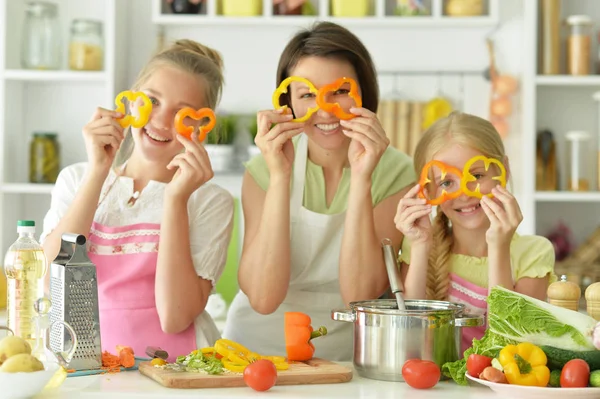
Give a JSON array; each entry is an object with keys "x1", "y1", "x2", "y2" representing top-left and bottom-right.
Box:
[{"x1": 41, "y1": 364, "x2": 498, "y2": 399}]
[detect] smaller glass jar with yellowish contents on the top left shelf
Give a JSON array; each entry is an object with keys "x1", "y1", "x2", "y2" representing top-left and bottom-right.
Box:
[{"x1": 69, "y1": 19, "x2": 104, "y2": 71}]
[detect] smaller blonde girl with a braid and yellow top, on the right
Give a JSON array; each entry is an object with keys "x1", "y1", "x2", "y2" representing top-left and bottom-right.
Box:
[{"x1": 395, "y1": 112, "x2": 556, "y2": 350}]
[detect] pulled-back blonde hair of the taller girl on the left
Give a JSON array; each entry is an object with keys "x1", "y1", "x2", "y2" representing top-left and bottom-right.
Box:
[{"x1": 113, "y1": 39, "x2": 225, "y2": 167}]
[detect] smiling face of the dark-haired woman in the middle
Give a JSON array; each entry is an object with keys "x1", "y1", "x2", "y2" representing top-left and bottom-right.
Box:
[{"x1": 289, "y1": 57, "x2": 360, "y2": 150}]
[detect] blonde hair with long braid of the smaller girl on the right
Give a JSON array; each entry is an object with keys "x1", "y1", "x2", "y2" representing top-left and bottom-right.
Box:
[{"x1": 414, "y1": 112, "x2": 506, "y2": 300}]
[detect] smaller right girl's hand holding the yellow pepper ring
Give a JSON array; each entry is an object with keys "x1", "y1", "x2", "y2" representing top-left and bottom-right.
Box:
[{"x1": 481, "y1": 186, "x2": 523, "y2": 245}]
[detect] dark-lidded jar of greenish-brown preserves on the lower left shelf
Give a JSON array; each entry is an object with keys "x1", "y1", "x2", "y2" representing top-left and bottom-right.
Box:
[{"x1": 29, "y1": 132, "x2": 60, "y2": 184}]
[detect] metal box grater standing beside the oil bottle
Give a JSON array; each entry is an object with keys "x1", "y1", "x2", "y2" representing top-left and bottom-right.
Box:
[{"x1": 50, "y1": 233, "x2": 102, "y2": 370}]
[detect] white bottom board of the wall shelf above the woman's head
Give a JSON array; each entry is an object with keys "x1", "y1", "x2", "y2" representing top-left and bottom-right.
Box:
[{"x1": 153, "y1": 14, "x2": 498, "y2": 28}]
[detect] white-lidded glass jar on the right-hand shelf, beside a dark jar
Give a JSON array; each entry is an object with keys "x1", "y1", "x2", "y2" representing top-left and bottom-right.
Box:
[{"x1": 566, "y1": 130, "x2": 594, "y2": 191}]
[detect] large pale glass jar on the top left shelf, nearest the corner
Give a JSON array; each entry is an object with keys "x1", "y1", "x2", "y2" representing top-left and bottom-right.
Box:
[{"x1": 21, "y1": 1, "x2": 62, "y2": 70}]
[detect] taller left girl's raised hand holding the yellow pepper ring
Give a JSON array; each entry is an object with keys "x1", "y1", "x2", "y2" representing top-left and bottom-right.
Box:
[{"x1": 82, "y1": 107, "x2": 125, "y2": 177}]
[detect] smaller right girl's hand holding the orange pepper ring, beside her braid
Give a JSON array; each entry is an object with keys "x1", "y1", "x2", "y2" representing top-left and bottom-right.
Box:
[{"x1": 394, "y1": 184, "x2": 431, "y2": 245}]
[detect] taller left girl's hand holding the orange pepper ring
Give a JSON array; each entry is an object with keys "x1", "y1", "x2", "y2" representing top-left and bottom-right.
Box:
[{"x1": 165, "y1": 134, "x2": 215, "y2": 201}]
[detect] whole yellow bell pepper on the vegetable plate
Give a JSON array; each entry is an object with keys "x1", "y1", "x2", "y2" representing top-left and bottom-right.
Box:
[{"x1": 498, "y1": 342, "x2": 550, "y2": 387}]
